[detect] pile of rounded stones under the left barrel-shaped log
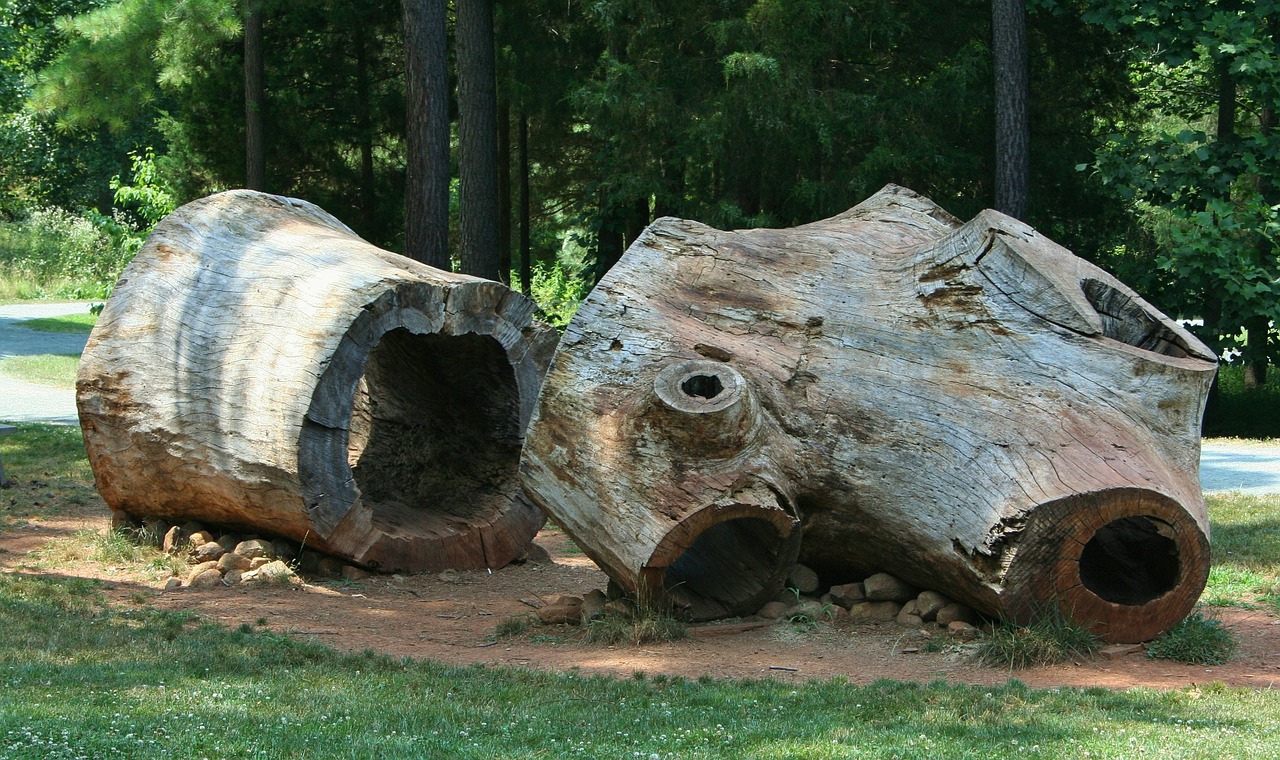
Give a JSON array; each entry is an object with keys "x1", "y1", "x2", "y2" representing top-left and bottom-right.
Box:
[{"x1": 111, "y1": 512, "x2": 370, "y2": 590}]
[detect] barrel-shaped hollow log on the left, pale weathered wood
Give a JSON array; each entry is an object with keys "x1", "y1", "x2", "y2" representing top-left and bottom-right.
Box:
[{"x1": 77, "y1": 191, "x2": 556, "y2": 571}]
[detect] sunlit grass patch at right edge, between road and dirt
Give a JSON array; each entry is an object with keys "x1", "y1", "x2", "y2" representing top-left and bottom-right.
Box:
[{"x1": 1202, "y1": 494, "x2": 1280, "y2": 610}]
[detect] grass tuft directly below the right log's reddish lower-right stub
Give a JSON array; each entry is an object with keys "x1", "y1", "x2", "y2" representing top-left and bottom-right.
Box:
[{"x1": 974, "y1": 609, "x2": 1102, "y2": 669}]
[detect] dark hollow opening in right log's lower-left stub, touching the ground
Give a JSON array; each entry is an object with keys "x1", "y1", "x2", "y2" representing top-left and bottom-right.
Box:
[{"x1": 663, "y1": 517, "x2": 785, "y2": 619}]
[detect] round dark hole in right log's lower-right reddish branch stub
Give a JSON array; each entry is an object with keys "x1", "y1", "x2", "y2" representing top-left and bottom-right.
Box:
[{"x1": 1080, "y1": 517, "x2": 1179, "y2": 605}]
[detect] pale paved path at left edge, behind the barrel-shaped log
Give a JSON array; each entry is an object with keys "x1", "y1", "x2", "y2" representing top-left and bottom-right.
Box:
[{"x1": 0, "y1": 303, "x2": 91, "y2": 425}]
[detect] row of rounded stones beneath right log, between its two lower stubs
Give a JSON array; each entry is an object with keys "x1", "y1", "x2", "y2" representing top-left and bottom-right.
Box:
[{"x1": 758, "y1": 564, "x2": 979, "y2": 638}]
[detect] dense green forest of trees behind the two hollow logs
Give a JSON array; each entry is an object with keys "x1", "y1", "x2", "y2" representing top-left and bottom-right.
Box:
[{"x1": 0, "y1": 0, "x2": 1280, "y2": 429}]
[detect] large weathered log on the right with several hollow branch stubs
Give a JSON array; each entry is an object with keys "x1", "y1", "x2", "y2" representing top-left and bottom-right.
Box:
[{"x1": 522, "y1": 186, "x2": 1216, "y2": 641}]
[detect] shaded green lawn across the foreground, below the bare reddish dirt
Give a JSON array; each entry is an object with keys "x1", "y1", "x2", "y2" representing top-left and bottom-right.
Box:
[{"x1": 0, "y1": 574, "x2": 1280, "y2": 760}]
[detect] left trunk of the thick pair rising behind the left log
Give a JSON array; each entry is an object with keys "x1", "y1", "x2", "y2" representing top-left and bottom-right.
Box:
[{"x1": 401, "y1": 0, "x2": 452, "y2": 271}]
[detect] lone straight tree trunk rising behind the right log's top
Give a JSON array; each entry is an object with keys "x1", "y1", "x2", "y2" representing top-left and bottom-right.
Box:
[{"x1": 991, "y1": 0, "x2": 1030, "y2": 219}]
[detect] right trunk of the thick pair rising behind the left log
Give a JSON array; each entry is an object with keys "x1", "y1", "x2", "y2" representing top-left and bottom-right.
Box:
[{"x1": 453, "y1": 0, "x2": 499, "y2": 280}]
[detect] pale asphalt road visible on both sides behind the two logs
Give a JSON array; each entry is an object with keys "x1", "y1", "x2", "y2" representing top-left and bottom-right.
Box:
[{"x1": 0, "y1": 303, "x2": 1280, "y2": 494}]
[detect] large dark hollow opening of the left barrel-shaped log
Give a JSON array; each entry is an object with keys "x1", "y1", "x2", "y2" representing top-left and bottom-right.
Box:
[{"x1": 348, "y1": 329, "x2": 520, "y2": 536}]
